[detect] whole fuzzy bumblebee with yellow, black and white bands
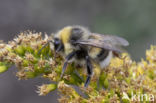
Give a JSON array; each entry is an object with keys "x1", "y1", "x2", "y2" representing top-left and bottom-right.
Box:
[{"x1": 39, "y1": 26, "x2": 129, "y2": 87}]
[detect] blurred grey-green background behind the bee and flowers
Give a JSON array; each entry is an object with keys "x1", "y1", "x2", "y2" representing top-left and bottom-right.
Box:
[{"x1": 0, "y1": 0, "x2": 156, "y2": 103}]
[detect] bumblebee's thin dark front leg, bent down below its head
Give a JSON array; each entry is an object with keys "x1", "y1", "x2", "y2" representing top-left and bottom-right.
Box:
[{"x1": 61, "y1": 51, "x2": 76, "y2": 78}]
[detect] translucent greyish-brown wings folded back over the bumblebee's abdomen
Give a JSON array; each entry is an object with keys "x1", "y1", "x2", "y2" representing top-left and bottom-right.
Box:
[{"x1": 76, "y1": 33, "x2": 129, "y2": 52}]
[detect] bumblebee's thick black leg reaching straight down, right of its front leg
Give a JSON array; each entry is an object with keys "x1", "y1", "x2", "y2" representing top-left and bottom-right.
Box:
[{"x1": 84, "y1": 56, "x2": 93, "y2": 87}]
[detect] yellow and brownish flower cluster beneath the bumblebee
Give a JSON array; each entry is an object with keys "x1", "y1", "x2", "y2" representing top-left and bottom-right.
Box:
[{"x1": 0, "y1": 31, "x2": 156, "y2": 103}]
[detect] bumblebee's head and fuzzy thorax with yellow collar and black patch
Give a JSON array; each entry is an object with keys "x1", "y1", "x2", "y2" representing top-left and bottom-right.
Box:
[{"x1": 54, "y1": 26, "x2": 88, "y2": 54}]
